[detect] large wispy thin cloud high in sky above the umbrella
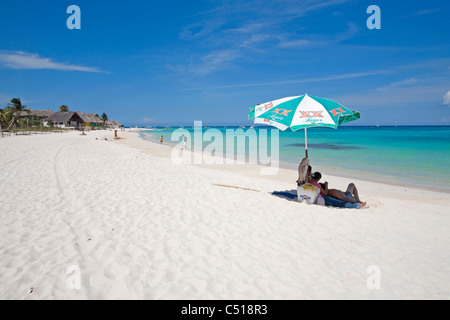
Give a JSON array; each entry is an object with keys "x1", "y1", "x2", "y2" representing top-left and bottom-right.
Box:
[{"x1": 173, "y1": 0, "x2": 358, "y2": 76}]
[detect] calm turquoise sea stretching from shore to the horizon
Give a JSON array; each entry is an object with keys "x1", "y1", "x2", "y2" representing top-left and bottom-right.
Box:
[{"x1": 142, "y1": 126, "x2": 450, "y2": 192}]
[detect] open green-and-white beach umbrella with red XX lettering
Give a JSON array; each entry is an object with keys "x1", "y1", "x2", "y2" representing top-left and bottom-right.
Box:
[{"x1": 248, "y1": 94, "x2": 361, "y2": 182}]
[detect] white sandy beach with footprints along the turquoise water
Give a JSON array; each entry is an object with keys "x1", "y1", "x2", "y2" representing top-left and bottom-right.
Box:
[{"x1": 0, "y1": 132, "x2": 450, "y2": 299}]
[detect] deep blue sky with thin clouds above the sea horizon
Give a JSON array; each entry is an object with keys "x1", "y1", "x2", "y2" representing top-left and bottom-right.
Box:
[{"x1": 0, "y1": 0, "x2": 450, "y2": 126}]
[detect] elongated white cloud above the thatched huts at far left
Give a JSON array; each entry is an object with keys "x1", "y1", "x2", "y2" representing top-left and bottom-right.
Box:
[{"x1": 0, "y1": 51, "x2": 108, "y2": 73}]
